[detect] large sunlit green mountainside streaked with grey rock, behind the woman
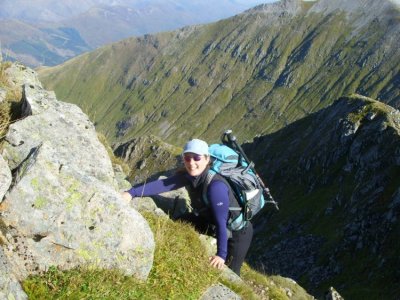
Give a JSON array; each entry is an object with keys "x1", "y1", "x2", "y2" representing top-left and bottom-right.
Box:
[{"x1": 40, "y1": 0, "x2": 400, "y2": 144}]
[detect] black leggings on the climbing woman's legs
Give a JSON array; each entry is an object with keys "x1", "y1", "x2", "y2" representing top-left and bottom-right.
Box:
[{"x1": 179, "y1": 213, "x2": 253, "y2": 276}]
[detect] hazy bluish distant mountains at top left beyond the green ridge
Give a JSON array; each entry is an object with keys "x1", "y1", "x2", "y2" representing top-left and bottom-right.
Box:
[{"x1": 0, "y1": 0, "x2": 270, "y2": 66}]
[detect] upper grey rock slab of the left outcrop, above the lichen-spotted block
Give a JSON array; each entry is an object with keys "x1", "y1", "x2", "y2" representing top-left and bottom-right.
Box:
[{"x1": 3, "y1": 86, "x2": 117, "y2": 187}]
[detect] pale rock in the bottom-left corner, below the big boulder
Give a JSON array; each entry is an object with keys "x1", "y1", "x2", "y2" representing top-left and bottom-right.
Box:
[{"x1": 0, "y1": 248, "x2": 28, "y2": 300}]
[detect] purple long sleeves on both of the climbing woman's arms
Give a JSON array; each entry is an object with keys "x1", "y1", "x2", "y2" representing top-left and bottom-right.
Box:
[{"x1": 128, "y1": 173, "x2": 229, "y2": 260}]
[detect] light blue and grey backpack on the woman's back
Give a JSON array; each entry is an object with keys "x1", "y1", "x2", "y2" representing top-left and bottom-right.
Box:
[{"x1": 202, "y1": 144, "x2": 265, "y2": 231}]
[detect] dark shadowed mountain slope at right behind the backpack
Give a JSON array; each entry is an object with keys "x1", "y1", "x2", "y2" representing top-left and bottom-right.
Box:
[{"x1": 244, "y1": 95, "x2": 400, "y2": 299}]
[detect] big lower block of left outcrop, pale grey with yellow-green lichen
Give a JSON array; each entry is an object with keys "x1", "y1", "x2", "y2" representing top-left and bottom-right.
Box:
[{"x1": 2, "y1": 143, "x2": 154, "y2": 279}]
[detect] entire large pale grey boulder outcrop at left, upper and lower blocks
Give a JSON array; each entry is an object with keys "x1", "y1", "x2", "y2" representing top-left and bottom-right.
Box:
[{"x1": 1, "y1": 65, "x2": 154, "y2": 280}]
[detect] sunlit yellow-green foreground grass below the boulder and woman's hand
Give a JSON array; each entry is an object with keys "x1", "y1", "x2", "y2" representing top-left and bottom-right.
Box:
[{"x1": 23, "y1": 213, "x2": 304, "y2": 300}]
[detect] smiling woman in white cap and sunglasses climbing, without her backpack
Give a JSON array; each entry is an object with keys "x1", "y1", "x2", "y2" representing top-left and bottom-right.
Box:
[{"x1": 122, "y1": 139, "x2": 253, "y2": 275}]
